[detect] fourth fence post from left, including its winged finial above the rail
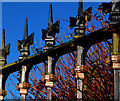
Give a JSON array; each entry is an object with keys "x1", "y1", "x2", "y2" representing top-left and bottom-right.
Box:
[{"x1": 70, "y1": 0, "x2": 92, "y2": 101}]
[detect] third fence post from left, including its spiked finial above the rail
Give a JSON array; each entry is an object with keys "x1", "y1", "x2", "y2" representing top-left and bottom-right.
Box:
[{"x1": 42, "y1": 4, "x2": 59, "y2": 101}]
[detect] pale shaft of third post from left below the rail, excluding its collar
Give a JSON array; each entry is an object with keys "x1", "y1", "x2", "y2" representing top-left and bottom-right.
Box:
[{"x1": 47, "y1": 56, "x2": 52, "y2": 101}]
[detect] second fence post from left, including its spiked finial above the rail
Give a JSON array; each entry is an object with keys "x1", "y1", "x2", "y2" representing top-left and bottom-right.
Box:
[{"x1": 16, "y1": 18, "x2": 34, "y2": 100}]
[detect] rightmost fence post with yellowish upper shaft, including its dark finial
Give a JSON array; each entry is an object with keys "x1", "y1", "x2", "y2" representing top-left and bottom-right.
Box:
[{"x1": 110, "y1": 0, "x2": 120, "y2": 101}]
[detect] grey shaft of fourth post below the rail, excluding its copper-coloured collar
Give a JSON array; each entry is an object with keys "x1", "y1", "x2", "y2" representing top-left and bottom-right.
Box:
[{"x1": 77, "y1": 46, "x2": 83, "y2": 101}]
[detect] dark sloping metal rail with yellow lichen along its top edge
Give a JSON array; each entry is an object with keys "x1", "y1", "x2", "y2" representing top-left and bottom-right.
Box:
[{"x1": 0, "y1": 26, "x2": 118, "y2": 74}]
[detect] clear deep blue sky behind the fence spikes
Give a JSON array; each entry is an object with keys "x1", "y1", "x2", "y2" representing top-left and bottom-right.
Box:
[{"x1": 2, "y1": 2, "x2": 110, "y2": 98}]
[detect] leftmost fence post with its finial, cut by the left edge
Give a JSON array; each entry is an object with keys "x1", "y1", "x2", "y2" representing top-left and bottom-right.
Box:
[{"x1": 0, "y1": 29, "x2": 10, "y2": 100}]
